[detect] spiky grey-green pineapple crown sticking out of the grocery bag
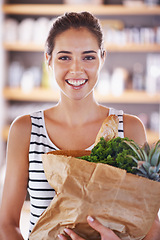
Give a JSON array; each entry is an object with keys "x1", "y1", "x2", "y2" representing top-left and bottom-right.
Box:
[{"x1": 125, "y1": 140, "x2": 160, "y2": 182}]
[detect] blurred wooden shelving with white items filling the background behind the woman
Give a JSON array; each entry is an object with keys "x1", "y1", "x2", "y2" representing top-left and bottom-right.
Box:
[{"x1": 0, "y1": 0, "x2": 160, "y2": 167}]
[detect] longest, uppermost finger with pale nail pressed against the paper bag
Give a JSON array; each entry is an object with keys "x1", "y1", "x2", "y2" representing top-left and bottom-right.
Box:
[{"x1": 87, "y1": 216, "x2": 120, "y2": 240}]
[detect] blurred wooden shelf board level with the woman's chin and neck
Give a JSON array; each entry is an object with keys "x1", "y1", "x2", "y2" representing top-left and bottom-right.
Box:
[{"x1": 3, "y1": 88, "x2": 160, "y2": 104}]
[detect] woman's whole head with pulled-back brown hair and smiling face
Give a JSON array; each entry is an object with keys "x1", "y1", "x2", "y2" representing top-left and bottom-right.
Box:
[{"x1": 46, "y1": 12, "x2": 105, "y2": 102}]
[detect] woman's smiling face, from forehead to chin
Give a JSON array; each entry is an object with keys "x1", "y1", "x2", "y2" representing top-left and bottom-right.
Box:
[{"x1": 50, "y1": 28, "x2": 104, "y2": 100}]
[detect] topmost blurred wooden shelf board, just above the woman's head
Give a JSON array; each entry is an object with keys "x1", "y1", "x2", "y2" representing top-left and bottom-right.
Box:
[{"x1": 2, "y1": 4, "x2": 160, "y2": 16}]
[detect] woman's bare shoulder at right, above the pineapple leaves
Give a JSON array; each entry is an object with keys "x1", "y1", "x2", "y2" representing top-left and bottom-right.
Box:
[{"x1": 123, "y1": 114, "x2": 147, "y2": 145}]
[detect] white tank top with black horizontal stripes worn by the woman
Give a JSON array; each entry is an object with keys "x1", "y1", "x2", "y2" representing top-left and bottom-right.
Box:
[{"x1": 28, "y1": 108, "x2": 124, "y2": 237}]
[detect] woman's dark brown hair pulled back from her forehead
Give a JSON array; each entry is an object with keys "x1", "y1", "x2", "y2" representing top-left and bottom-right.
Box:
[{"x1": 46, "y1": 12, "x2": 104, "y2": 58}]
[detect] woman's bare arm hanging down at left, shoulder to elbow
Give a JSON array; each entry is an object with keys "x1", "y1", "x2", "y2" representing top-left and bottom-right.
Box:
[{"x1": 0, "y1": 116, "x2": 31, "y2": 240}]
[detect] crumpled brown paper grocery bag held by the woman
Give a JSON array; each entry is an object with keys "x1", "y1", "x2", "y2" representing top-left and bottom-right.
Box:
[{"x1": 29, "y1": 151, "x2": 160, "y2": 240}]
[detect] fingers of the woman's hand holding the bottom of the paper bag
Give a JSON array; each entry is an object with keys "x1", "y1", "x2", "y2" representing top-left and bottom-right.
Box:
[{"x1": 58, "y1": 216, "x2": 120, "y2": 240}]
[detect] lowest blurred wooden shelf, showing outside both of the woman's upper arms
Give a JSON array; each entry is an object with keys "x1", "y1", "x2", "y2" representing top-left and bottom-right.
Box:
[{"x1": 2, "y1": 126, "x2": 159, "y2": 144}]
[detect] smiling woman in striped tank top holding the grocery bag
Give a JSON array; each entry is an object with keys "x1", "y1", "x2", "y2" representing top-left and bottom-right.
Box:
[{"x1": 0, "y1": 12, "x2": 158, "y2": 240}]
